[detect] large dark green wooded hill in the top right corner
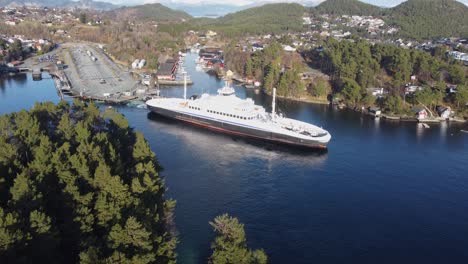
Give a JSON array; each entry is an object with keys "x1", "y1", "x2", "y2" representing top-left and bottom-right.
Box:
[{"x1": 389, "y1": 0, "x2": 468, "y2": 39}]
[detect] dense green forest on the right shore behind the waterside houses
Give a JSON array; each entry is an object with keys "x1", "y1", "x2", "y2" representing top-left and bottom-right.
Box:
[{"x1": 304, "y1": 39, "x2": 468, "y2": 112}]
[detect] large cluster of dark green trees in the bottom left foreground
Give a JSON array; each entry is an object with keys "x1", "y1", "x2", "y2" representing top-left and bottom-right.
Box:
[{"x1": 0, "y1": 101, "x2": 176, "y2": 263}]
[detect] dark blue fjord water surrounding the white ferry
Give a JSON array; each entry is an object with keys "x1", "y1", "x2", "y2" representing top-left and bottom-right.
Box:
[{"x1": 0, "y1": 55, "x2": 468, "y2": 263}]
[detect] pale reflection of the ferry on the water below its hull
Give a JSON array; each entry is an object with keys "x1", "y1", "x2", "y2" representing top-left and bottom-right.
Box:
[{"x1": 148, "y1": 112, "x2": 328, "y2": 166}]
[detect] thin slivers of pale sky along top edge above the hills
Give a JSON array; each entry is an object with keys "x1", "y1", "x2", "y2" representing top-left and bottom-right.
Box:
[{"x1": 100, "y1": 0, "x2": 468, "y2": 7}]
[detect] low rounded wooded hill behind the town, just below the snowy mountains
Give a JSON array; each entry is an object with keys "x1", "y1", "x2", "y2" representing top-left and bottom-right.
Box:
[{"x1": 107, "y1": 3, "x2": 192, "y2": 22}]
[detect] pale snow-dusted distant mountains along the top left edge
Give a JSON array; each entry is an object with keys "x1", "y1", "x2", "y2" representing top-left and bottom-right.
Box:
[{"x1": 0, "y1": 0, "x2": 117, "y2": 10}]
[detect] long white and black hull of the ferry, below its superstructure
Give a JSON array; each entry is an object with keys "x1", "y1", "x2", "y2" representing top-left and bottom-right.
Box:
[{"x1": 147, "y1": 96, "x2": 331, "y2": 149}]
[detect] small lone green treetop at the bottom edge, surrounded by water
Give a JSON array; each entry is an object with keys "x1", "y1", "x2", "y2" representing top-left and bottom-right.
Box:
[{"x1": 209, "y1": 214, "x2": 268, "y2": 264}]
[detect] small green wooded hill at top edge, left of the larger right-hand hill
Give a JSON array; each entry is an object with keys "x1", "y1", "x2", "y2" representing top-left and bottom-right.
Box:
[{"x1": 312, "y1": 0, "x2": 382, "y2": 16}]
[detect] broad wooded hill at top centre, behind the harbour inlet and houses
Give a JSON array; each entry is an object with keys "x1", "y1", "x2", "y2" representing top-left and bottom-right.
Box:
[{"x1": 205, "y1": 4, "x2": 308, "y2": 36}]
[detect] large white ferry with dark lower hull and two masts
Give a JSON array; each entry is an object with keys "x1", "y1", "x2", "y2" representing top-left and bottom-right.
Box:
[{"x1": 146, "y1": 84, "x2": 331, "y2": 149}]
